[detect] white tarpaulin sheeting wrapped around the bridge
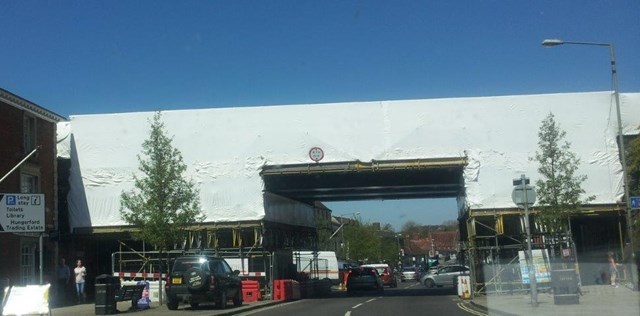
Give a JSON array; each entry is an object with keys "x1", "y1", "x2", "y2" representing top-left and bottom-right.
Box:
[{"x1": 59, "y1": 92, "x2": 640, "y2": 227}]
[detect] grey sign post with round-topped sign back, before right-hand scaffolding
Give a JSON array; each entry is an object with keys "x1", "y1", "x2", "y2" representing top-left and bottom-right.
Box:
[{"x1": 511, "y1": 174, "x2": 538, "y2": 307}]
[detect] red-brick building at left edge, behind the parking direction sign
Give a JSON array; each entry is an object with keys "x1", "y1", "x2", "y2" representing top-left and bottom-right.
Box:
[{"x1": 0, "y1": 89, "x2": 65, "y2": 285}]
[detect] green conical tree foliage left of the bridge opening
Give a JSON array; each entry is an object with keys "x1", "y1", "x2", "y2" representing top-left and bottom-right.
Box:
[{"x1": 120, "y1": 112, "x2": 204, "y2": 251}]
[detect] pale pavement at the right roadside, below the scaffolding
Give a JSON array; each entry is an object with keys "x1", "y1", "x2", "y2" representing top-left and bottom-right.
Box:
[{"x1": 468, "y1": 285, "x2": 640, "y2": 316}]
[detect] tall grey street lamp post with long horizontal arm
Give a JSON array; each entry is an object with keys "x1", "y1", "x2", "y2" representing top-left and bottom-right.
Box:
[{"x1": 542, "y1": 39, "x2": 637, "y2": 288}]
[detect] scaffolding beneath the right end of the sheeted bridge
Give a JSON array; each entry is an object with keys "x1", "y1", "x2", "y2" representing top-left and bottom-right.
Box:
[{"x1": 462, "y1": 205, "x2": 624, "y2": 294}]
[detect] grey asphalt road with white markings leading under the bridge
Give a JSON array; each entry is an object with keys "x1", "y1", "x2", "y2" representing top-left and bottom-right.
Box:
[{"x1": 240, "y1": 282, "x2": 481, "y2": 316}]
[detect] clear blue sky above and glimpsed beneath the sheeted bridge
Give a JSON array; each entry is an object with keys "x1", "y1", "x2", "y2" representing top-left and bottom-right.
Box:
[{"x1": 0, "y1": 0, "x2": 640, "y2": 231}]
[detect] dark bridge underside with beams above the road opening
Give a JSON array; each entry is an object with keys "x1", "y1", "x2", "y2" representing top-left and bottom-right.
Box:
[{"x1": 261, "y1": 158, "x2": 466, "y2": 203}]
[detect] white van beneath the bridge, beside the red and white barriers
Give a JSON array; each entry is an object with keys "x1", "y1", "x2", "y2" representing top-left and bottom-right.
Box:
[{"x1": 293, "y1": 251, "x2": 340, "y2": 285}]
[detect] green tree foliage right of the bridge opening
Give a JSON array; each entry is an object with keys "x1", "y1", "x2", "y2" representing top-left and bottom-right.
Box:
[{"x1": 532, "y1": 113, "x2": 593, "y2": 233}]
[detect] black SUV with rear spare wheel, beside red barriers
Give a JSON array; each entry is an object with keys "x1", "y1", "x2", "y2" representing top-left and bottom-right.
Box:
[{"x1": 165, "y1": 256, "x2": 242, "y2": 310}]
